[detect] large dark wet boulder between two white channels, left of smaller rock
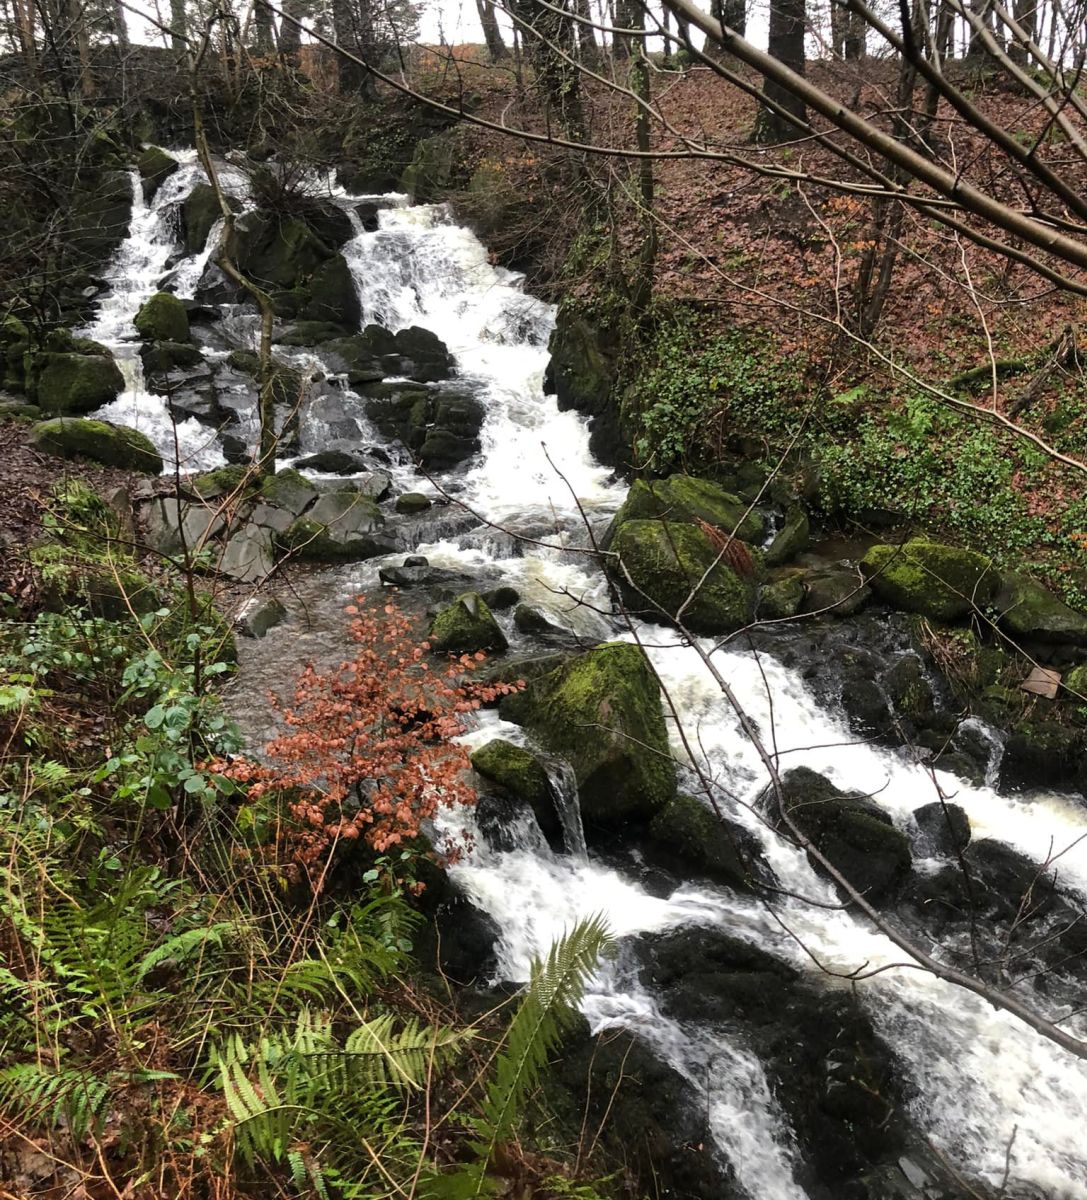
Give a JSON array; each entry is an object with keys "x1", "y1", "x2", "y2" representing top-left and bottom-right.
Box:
[{"x1": 768, "y1": 767, "x2": 911, "y2": 904}]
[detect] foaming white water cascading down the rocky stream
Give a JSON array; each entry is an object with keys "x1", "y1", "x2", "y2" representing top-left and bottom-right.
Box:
[{"x1": 86, "y1": 156, "x2": 1087, "y2": 1200}]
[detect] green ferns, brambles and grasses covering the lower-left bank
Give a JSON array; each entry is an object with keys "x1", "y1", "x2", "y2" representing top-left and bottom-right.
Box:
[{"x1": 0, "y1": 485, "x2": 608, "y2": 1200}]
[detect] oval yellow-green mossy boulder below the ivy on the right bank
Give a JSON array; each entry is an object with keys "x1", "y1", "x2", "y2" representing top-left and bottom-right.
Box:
[{"x1": 860, "y1": 539, "x2": 999, "y2": 620}]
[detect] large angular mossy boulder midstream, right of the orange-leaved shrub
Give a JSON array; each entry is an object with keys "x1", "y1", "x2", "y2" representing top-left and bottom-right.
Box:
[{"x1": 500, "y1": 642, "x2": 675, "y2": 830}]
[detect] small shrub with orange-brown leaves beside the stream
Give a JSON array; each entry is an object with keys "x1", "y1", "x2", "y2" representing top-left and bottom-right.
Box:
[{"x1": 211, "y1": 596, "x2": 521, "y2": 892}]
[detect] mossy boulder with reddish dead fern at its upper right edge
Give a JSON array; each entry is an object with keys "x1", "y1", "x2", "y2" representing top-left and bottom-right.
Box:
[{"x1": 607, "y1": 521, "x2": 758, "y2": 634}]
